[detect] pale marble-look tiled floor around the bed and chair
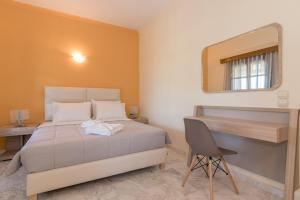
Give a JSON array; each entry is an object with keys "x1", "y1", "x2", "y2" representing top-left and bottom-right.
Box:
[{"x1": 0, "y1": 150, "x2": 280, "y2": 200}]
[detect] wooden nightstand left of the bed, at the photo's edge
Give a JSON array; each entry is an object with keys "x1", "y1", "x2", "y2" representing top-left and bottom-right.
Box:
[{"x1": 0, "y1": 124, "x2": 38, "y2": 161}]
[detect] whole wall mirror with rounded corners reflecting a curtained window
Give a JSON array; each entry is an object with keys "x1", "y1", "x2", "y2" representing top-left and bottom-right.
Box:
[{"x1": 202, "y1": 24, "x2": 282, "y2": 92}]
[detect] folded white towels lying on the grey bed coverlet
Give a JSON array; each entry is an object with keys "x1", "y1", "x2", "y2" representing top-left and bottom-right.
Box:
[{"x1": 85, "y1": 123, "x2": 124, "y2": 136}]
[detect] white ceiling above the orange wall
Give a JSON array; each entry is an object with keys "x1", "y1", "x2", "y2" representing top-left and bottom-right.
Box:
[{"x1": 15, "y1": 0, "x2": 170, "y2": 29}]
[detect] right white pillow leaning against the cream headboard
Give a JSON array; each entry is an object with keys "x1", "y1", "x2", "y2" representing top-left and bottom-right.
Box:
[{"x1": 95, "y1": 101, "x2": 128, "y2": 121}]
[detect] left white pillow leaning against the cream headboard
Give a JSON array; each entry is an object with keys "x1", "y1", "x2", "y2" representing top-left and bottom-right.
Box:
[{"x1": 52, "y1": 102, "x2": 91, "y2": 122}]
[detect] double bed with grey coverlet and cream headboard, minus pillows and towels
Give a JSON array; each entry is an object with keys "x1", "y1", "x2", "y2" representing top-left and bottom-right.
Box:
[{"x1": 20, "y1": 87, "x2": 167, "y2": 200}]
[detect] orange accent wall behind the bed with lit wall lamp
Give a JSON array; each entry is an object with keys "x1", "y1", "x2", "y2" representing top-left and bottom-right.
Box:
[{"x1": 0, "y1": 0, "x2": 139, "y2": 148}]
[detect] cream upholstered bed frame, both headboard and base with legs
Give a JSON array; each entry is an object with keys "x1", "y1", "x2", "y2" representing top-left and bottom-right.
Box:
[{"x1": 26, "y1": 87, "x2": 167, "y2": 200}]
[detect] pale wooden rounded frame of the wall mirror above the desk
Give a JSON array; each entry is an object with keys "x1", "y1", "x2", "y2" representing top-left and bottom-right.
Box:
[{"x1": 201, "y1": 23, "x2": 282, "y2": 94}]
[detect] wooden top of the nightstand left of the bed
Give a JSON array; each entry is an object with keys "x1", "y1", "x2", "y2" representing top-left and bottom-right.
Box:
[{"x1": 0, "y1": 124, "x2": 38, "y2": 137}]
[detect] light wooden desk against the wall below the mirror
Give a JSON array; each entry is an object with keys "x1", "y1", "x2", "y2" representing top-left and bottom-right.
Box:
[{"x1": 188, "y1": 106, "x2": 299, "y2": 200}]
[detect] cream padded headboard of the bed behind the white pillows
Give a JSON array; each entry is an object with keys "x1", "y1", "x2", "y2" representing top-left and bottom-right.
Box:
[{"x1": 45, "y1": 86, "x2": 120, "y2": 121}]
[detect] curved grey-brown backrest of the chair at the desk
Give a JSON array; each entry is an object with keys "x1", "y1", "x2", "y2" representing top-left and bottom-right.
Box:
[{"x1": 184, "y1": 118, "x2": 221, "y2": 156}]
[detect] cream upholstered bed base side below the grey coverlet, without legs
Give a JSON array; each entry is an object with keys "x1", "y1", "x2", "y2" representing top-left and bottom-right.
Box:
[{"x1": 26, "y1": 148, "x2": 167, "y2": 196}]
